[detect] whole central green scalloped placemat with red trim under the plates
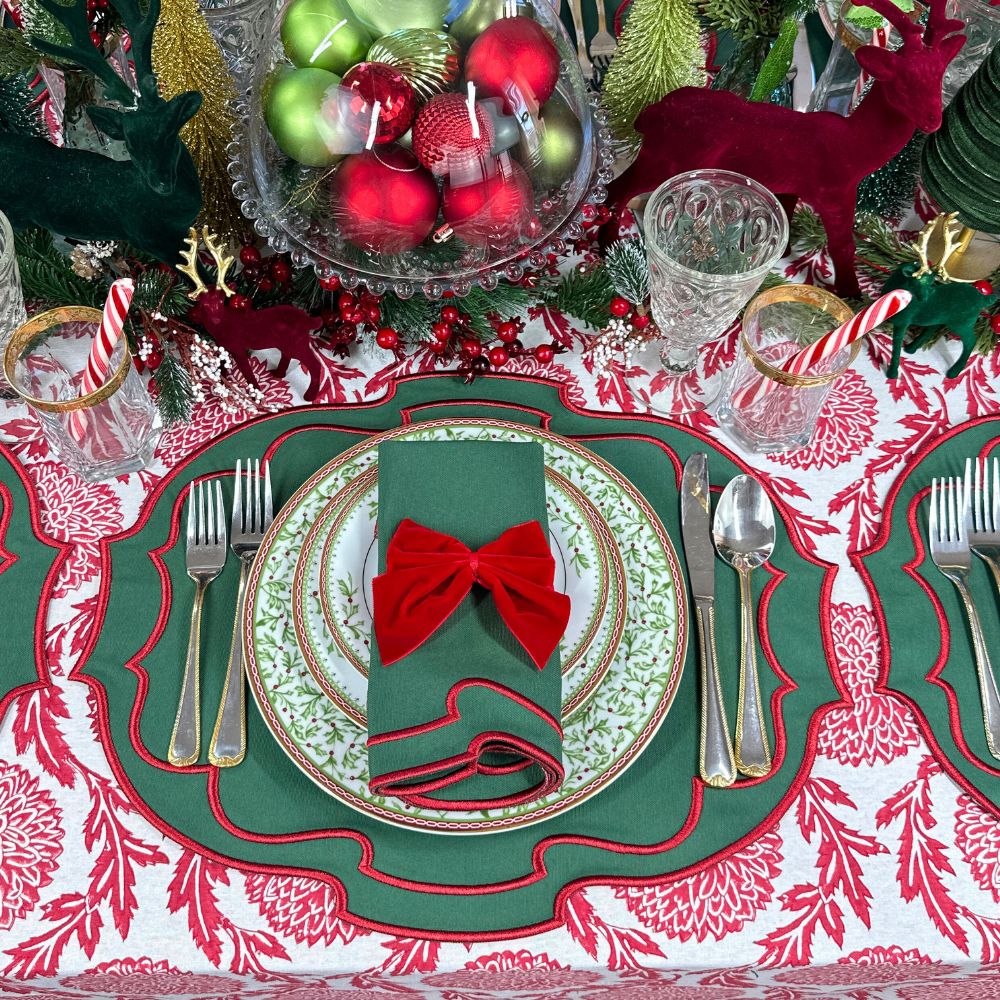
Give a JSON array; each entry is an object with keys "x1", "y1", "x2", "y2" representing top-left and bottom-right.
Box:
[{"x1": 82, "y1": 376, "x2": 840, "y2": 938}]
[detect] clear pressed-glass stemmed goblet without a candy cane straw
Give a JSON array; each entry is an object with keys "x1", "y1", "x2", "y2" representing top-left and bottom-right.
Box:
[{"x1": 635, "y1": 170, "x2": 788, "y2": 415}]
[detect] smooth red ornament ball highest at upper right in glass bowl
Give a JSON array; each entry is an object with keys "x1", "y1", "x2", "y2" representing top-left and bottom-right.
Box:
[{"x1": 465, "y1": 17, "x2": 559, "y2": 115}]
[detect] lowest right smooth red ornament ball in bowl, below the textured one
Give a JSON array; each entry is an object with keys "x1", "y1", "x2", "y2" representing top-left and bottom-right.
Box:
[{"x1": 441, "y1": 161, "x2": 532, "y2": 246}]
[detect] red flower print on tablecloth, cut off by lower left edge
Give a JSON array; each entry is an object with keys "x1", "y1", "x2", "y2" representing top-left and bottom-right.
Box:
[{"x1": 0, "y1": 761, "x2": 63, "y2": 931}]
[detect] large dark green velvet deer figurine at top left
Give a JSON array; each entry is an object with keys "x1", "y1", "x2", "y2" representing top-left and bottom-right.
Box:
[{"x1": 0, "y1": 0, "x2": 201, "y2": 264}]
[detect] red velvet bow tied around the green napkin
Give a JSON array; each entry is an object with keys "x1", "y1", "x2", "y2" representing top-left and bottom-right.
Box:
[{"x1": 372, "y1": 518, "x2": 569, "y2": 670}]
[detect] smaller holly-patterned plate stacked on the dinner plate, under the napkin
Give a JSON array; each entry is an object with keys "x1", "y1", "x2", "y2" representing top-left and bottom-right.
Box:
[{"x1": 292, "y1": 460, "x2": 625, "y2": 726}]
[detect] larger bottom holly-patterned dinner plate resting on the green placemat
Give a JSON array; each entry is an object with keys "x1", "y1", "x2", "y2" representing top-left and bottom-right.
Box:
[{"x1": 244, "y1": 419, "x2": 688, "y2": 834}]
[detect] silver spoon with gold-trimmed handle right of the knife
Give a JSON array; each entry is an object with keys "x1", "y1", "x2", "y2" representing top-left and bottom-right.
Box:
[{"x1": 712, "y1": 476, "x2": 774, "y2": 778}]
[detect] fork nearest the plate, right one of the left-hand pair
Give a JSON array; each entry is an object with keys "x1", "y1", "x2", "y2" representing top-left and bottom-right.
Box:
[{"x1": 208, "y1": 458, "x2": 274, "y2": 767}]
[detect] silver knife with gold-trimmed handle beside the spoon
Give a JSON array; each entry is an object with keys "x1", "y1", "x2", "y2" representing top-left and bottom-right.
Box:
[{"x1": 681, "y1": 451, "x2": 736, "y2": 788}]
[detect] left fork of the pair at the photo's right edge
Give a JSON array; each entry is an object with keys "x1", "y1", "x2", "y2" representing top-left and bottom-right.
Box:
[{"x1": 928, "y1": 476, "x2": 1000, "y2": 760}]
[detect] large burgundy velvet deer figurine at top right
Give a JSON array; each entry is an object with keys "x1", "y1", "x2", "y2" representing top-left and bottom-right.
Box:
[{"x1": 608, "y1": 0, "x2": 965, "y2": 296}]
